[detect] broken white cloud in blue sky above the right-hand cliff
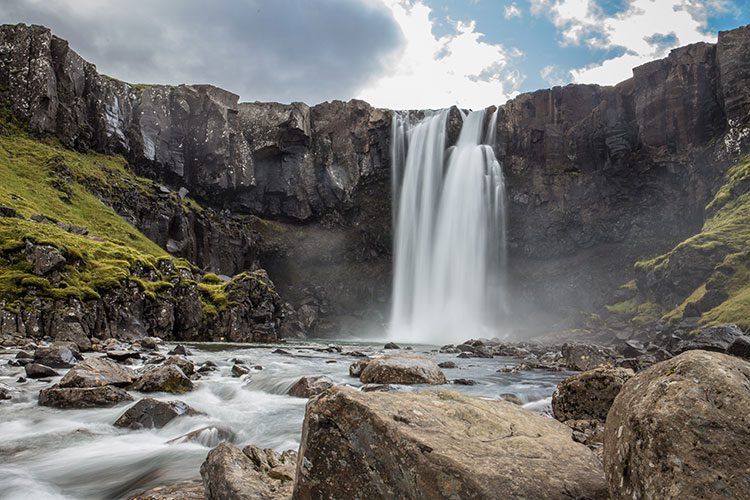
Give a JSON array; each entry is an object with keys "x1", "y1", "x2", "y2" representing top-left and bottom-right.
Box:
[{"x1": 531, "y1": 0, "x2": 734, "y2": 85}]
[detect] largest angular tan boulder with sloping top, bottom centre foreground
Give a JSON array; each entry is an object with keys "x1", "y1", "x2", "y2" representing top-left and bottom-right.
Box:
[{"x1": 294, "y1": 387, "x2": 606, "y2": 499}]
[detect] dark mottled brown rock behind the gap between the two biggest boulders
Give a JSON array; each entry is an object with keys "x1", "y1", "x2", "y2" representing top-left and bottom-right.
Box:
[{"x1": 552, "y1": 367, "x2": 633, "y2": 422}]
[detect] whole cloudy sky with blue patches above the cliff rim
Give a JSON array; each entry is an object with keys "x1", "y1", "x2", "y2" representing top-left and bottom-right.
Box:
[{"x1": 0, "y1": 0, "x2": 750, "y2": 109}]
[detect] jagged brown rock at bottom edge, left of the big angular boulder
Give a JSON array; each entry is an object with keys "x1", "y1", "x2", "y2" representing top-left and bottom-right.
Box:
[{"x1": 201, "y1": 443, "x2": 294, "y2": 500}]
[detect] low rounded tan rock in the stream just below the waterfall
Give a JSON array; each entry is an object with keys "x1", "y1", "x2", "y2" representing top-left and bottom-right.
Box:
[{"x1": 359, "y1": 356, "x2": 447, "y2": 384}]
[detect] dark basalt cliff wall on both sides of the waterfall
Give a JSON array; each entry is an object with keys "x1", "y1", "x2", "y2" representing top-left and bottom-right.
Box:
[{"x1": 0, "y1": 25, "x2": 750, "y2": 336}]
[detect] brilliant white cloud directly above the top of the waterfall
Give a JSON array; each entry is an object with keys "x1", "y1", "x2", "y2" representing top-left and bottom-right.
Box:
[{"x1": 358, "y1": 0, "x2": 523, "y2": 109}]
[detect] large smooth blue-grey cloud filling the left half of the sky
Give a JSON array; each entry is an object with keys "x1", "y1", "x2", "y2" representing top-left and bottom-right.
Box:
[{"x1": 0, "y1": 0, "x2": 404, "y2": 103}]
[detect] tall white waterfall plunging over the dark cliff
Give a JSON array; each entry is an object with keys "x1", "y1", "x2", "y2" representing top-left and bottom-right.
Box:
[{"x1": 389, "y1": 110, "x2": 507, "y2": 344}]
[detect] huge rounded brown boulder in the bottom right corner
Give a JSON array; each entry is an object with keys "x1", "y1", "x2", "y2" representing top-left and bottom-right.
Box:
[{"x1": 604, "y1": 350, "x2": 750, "y2": 499}]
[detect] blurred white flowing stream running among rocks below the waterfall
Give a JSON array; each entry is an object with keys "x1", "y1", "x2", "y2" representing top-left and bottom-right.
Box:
[{"x1": 0, "y1": 342, "x2": 566, "y2": 499}]
